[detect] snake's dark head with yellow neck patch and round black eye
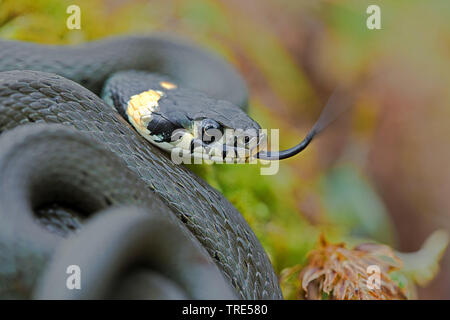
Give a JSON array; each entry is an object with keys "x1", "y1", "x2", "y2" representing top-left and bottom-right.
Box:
[{"x1": 108, "y1": 71, "x2": 264, "y2": 162}]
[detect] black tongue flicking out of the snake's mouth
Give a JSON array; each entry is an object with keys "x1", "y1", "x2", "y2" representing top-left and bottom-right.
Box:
[{"x1": 256, "y1": 88, "x2": 351, "y2": 160}]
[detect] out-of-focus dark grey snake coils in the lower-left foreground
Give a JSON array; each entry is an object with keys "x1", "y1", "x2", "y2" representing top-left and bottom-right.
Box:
[{"x1": 0, "y1": 123, "x2": 236, "y2": 299}]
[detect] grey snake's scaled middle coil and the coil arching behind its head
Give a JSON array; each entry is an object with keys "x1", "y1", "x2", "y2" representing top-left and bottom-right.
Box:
[{"x1": 0, "y1": 36, "x2": 282, "y2": 299}]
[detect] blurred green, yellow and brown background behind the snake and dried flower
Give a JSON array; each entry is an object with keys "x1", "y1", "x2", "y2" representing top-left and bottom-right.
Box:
[{"x1": 0, "y1": 0, "x2": 450, "y2": 299}]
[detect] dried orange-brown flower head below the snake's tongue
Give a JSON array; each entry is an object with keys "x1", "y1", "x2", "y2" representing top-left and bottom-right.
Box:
[{"x1": 300, "y1": 235, "x2": 406, "y2": 300}]
